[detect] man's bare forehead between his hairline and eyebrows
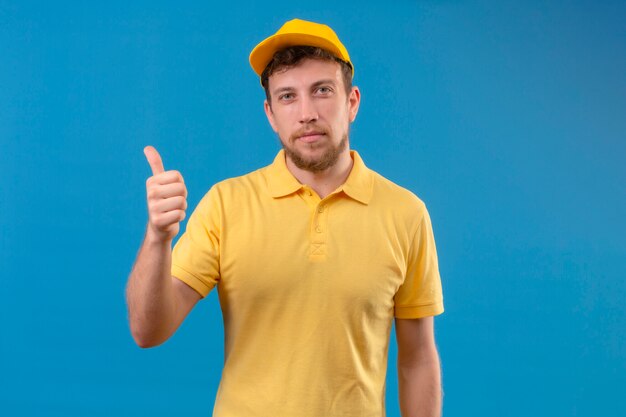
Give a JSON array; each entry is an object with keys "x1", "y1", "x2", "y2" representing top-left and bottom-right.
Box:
[{"x1": 268, "y1": 58, "x2": 343, "y2": 91}]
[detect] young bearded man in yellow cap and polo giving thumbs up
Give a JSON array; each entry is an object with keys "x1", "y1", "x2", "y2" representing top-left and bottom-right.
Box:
[{"x1": 127, "y1": 19, "x2": 443, "y2": 417}]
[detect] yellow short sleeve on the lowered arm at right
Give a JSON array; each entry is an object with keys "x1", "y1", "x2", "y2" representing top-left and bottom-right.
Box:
[{"x1": 394, "y1": 207, "x2": 443, "y2": 319}]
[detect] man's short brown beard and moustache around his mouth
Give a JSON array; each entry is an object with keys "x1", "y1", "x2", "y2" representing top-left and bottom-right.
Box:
[{"x1": 280, "y1": 129, "x2": 348, "y2": 173}]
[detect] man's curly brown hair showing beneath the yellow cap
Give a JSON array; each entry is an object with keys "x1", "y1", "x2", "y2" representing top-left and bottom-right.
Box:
[{"x1": 261, "y1": 45, "x2": 352, "y2": 107}]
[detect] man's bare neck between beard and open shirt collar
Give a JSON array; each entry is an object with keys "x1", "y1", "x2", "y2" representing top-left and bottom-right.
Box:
[{"x1": 285, "y1": 147, "x2": 353, "y2": 198}]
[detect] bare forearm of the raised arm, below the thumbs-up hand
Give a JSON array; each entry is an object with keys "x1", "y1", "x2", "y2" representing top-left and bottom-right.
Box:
[{"x1": 126, "y1": 229, "x2": 176, "y2": 347}]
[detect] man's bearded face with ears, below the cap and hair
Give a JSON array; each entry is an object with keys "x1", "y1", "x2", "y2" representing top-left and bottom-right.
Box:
[{"x1": 265, "y1": 59, "x2": 360, "y2": 172}]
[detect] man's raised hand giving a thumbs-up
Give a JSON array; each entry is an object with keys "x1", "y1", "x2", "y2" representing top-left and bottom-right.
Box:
[{"x1": 143, "y1": 146, "x2": 187, "y2": 242}]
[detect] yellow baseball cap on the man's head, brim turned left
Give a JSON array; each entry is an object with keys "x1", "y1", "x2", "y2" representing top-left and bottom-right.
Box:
[{"x1": 250, "y1": 19, "x2": 354, "y2": 77}]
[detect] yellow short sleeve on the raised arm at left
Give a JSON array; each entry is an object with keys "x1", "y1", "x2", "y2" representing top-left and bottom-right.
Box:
[{"x1": 172, "y1": 187, "x2": 221, "y2": 297}]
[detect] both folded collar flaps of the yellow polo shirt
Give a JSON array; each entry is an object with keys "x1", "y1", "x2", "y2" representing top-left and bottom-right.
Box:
[{"x1": 267, "y1": 149, "x2": 373, "y2": 204}]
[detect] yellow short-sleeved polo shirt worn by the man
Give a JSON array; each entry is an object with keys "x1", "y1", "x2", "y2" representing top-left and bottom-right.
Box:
[{"x1": 172, "y1": 151, "x2": 443, "y2": 417}]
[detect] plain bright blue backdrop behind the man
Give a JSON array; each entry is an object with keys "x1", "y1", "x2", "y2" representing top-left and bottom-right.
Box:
[{"x1": 0, "y1": 0, "x2": 626, "y2": 417}]
